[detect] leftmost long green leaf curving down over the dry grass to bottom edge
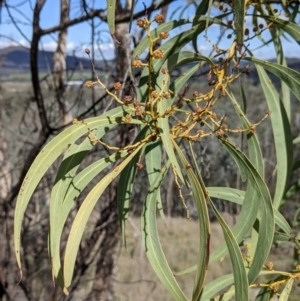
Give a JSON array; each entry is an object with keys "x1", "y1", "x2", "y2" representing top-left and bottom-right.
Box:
[{"x1": 141, "y1": 162, "x2": 188, "y2": 301}]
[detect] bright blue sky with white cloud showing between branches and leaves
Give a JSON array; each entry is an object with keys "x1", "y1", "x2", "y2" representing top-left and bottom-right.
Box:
[{"x1": 0, "y1": 0, "x2": 300, "y2": 59}]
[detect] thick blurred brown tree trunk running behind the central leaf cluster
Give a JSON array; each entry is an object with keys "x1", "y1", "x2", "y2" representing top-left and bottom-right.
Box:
[{"x1": 87, "y1": 0, "x2": 132, "y2": 301}]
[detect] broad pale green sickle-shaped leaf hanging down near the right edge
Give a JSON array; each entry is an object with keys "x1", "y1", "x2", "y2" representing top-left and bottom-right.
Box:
[{"x1": 256, "y1": 66, "x2": 293, "y2": 208}]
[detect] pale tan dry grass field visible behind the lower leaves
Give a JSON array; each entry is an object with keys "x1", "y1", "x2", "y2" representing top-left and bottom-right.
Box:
[{"x1": 114, "y1": 218, "x2": 299, "y2": 301}]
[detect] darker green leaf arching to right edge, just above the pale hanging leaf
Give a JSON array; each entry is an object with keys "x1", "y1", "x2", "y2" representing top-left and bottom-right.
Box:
[{"x1": 245, "y1": 57, "x2": 300, "y2": 100}]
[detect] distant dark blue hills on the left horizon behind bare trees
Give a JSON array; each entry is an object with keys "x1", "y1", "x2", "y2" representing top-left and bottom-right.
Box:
[{"x1": 0, "y1": 46, "x2": 111, "y2": 77}]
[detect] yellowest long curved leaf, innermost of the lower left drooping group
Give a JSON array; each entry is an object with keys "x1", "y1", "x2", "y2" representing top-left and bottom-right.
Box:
[{"x1": 63, "y1": 143, "x2": 144, "y2": 287}]
